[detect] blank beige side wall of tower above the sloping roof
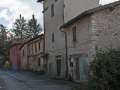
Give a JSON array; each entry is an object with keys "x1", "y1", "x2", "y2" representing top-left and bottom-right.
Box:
[{"x1": 64, "y1": 0, "x2": 99, "y2": 23}]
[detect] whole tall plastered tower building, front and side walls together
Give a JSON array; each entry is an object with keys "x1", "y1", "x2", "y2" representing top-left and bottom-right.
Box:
[{"x1": 38, "y1": 0, "x2": 98, "y2": 78}]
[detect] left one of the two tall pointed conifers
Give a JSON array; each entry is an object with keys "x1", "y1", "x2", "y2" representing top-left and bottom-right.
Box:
[{"x1": 12, "y1": 14, "x2": 29, "y2": 39}]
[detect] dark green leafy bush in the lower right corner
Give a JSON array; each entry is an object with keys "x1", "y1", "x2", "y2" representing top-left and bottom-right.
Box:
[{"x1": 89, "y1": 49, "x2": 120, "y2": 90}]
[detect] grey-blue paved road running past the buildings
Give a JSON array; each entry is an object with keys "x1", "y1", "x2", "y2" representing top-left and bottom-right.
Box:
[{"x1": 0, "y1": 70, "x2": 77, "y2": 90}]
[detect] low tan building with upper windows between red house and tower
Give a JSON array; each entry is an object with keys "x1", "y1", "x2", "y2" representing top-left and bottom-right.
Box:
[{"x1": 21, "y1": 34, "x2": 46, "y2": 72}]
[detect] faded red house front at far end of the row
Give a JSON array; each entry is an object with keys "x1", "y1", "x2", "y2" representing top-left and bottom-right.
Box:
[{"x1": 9, "y1": 40, "x2": 22, "y2": 71}]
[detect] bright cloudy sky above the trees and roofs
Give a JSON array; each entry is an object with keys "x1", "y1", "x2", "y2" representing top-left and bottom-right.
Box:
[{"x1": 0, "y1": 0, "x2": 117, "y2": 28}]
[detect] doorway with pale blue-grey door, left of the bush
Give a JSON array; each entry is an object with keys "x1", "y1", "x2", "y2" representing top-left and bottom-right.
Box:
[{"x1": 70, "y1": 55, "x2": 88, "y2": 82}]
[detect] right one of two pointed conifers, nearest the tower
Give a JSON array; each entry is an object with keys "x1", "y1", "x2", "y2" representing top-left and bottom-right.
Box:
[{"x1": 28, "y1": 14, "x2": 42, "y2": 37}]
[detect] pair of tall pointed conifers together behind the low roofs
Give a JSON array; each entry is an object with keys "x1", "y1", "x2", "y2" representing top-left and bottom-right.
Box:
[{"x1": 12, "y1": 15, "x2": 42, "y2": 39}]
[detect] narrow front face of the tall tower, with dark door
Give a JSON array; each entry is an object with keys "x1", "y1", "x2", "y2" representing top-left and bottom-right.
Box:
[{"x1": 40, "y1": 0, "x2": 66, "y2": 78}]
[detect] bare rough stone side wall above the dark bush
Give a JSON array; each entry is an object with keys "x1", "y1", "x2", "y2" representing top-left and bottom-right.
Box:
[{"x1": 92, "y1": 6, "x2": 120, "y2": 49}]
